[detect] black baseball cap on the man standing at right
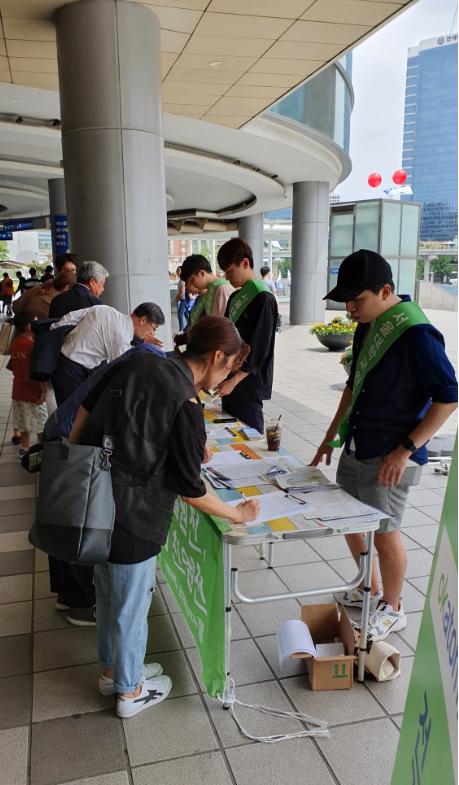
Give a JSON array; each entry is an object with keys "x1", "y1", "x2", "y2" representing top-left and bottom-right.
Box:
[{"x1": 323, "y1": 248, "x2": 394, "y2": 303}]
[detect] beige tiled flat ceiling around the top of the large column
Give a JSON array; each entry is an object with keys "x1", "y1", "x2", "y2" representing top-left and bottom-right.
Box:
[{"x1": 0, "y1": 0, "x2": 416, "y2": 128}]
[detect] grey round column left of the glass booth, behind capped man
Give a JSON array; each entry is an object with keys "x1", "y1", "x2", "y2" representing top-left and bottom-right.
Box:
[{"x1": 290, "y1": 182, "x2": 330, "y2": 324}]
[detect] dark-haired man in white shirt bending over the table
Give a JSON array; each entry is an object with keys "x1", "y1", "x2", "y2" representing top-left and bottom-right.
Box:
[{"x1": 52, "y1": 303, "x2": 165, "y2": 405}]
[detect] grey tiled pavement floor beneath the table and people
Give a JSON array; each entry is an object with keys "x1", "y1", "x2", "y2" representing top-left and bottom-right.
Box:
[{"x1": 0, "y1": 306, "x2": 455, "y2": 785}]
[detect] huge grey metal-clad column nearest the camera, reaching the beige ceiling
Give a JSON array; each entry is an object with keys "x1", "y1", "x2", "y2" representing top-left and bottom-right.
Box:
[{"x1": 56, "y1": 0, "x2": 171, "y2": 344}]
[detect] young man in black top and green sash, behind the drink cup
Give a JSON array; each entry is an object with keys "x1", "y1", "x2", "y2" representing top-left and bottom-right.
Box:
[{"x1": 218, "y1": 237, "x2": 278, "y2": 433}]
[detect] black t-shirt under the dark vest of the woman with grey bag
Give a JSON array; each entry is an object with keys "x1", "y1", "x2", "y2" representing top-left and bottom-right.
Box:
[{"x1": 82, "y1": 366, "x2": 207, "y2": 564}]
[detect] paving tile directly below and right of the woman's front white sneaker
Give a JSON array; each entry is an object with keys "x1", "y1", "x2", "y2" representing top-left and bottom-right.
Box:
[{"x1": 123, "y1": 695, "x2": 218, "y2": 764}]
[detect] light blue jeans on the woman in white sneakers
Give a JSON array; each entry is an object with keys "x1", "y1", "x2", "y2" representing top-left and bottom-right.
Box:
[{"x1": 94, "y1": 556, "x2": 156, "y2": 693}]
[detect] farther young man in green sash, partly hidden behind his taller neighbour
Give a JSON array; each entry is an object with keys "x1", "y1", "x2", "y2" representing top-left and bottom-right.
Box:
[{"x1": 180, "y1": 254, "x2": 234, "y2": 325}]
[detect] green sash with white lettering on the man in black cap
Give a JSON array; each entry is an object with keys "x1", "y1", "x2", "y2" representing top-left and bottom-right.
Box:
[{"x1": 327, "y1": 302, "x2": 429, "y2": 447}]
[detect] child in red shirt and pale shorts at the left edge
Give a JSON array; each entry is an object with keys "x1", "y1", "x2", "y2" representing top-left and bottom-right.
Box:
[{"x1": 10, "y1": 311, "x2": 48, "y2": 457}]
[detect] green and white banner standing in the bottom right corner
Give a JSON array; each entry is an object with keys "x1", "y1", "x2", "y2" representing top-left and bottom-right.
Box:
[{"x1": 392, "y1": 439, "x2": 458, "y2": 785}]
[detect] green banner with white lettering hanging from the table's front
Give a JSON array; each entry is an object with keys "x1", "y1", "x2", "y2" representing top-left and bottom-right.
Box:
[{"x1": 159, "y1": 499, "x2": 229, "y2": 698}]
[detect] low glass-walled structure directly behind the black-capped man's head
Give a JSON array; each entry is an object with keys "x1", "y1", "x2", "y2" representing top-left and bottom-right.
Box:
[{"x1": 328, "y1": 199, "x2": 420, "y2": 308}]
